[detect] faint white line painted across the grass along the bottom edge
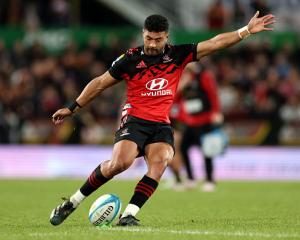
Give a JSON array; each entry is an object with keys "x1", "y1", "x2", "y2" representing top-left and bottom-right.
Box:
[{"x1": 25, "y1": 227, "x2": 300, "y2": 239}]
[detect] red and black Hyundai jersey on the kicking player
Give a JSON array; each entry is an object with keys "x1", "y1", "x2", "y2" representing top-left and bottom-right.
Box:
[{"x1": 108, "y1": 44, "x2": 197, "y2": 123}]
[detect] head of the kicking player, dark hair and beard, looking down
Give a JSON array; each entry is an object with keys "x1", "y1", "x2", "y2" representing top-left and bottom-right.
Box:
[{"x1": 143, "y1": 14, "x2": 169, "y2": 56}]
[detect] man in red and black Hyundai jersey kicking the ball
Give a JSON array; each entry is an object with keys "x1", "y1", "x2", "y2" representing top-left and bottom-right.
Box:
[{"x1": 50, "y1": 12, "x2": 275, "y2": 226}]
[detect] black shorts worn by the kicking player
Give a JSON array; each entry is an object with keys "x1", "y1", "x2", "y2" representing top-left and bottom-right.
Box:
[{"x1": 115, "y1": 115, "x2": 175, "y2": 157}]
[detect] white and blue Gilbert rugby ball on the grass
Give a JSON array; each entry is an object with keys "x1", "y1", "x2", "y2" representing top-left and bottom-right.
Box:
[{"x1": 89, "y1": 194, "x2": 121, "y2": 226}]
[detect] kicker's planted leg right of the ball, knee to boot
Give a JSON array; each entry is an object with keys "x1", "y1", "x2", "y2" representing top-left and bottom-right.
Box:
[{"x1": 118, "y1": 142, "x2": 174, "y2": 226}]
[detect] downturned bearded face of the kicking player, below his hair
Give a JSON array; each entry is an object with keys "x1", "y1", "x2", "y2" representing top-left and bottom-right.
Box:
[{"x1": 143, "y1": 29, "x2": 169, "y2": 56}]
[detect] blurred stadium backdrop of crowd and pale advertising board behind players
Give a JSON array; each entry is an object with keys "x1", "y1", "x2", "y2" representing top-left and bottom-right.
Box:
[{"x1": 0, "y1": 0, "x2": 300, "y2": 180}]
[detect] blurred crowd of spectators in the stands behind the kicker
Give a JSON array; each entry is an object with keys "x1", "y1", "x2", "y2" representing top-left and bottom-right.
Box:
[{"x1": 0, "y1": 35, "x2": 300, "y2": 144}]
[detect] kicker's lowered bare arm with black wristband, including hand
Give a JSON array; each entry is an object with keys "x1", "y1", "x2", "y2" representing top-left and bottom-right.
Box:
[{"x1": 52, "y1": 71, "x2": 120, "y2": 124}]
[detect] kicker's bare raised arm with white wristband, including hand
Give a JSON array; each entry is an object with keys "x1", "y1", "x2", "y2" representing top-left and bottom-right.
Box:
[{"x1": 197, "y1": 11, "x2": 275, "y2": 59}]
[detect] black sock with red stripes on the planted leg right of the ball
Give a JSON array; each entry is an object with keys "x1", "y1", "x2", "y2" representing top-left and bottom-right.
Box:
[{"x1": 129, "y1": 175, "x2": 158, "y2": 208}]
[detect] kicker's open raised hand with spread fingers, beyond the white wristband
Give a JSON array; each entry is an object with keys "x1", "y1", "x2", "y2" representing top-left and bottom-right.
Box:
[{"x1": 248, "y1": 11, "x2": 276, "y2": 34}]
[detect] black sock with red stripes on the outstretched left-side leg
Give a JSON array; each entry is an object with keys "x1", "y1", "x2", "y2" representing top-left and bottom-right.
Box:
[{"x1": 80, "y1": 164, "x2": 110, "y2": 196}]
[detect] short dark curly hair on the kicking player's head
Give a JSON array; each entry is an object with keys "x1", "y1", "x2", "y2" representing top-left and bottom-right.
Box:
[{"x1": 144, "y1": 14, "x2": 169, "y2": 32}]
